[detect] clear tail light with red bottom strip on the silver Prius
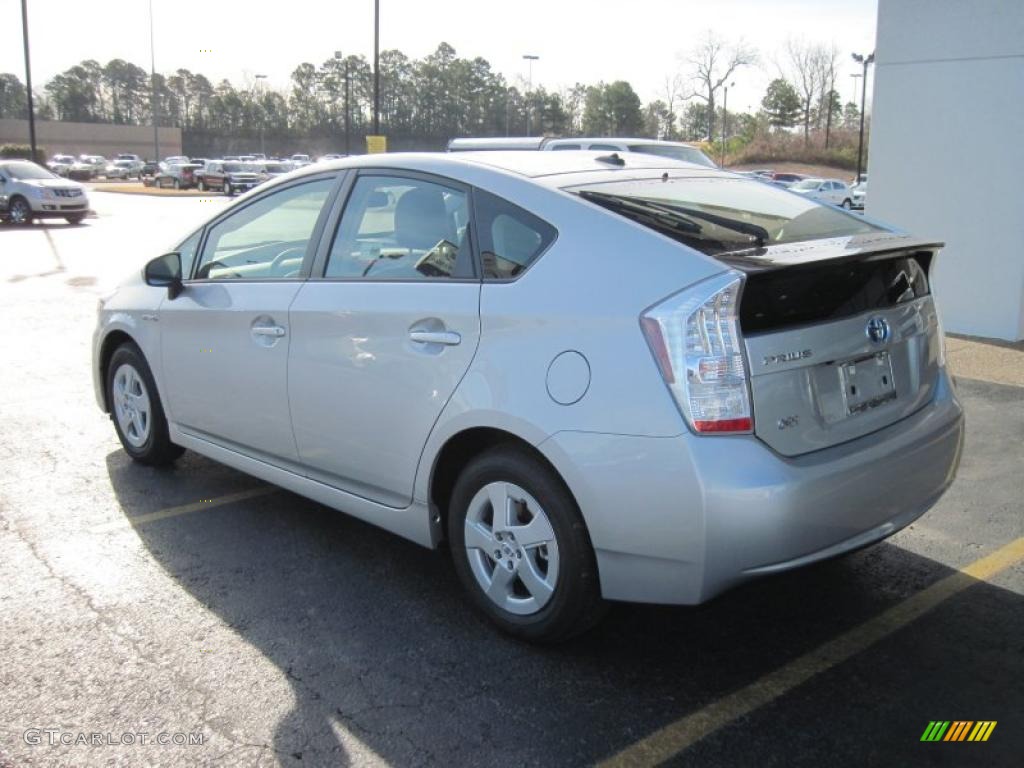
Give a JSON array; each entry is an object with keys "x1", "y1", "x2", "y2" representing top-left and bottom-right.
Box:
[{"x1": 640, "y1": 272, "x2": 754, "y2": 434}]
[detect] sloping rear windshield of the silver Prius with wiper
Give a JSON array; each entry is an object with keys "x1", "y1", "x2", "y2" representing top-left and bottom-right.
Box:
[{"x1": 568, "y1": 177, "x2": 883, "y2": 254}]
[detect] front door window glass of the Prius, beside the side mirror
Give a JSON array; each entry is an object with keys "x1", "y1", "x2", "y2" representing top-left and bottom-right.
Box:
[{"x1": 196, "y1": 178, "x2": 335, "y2": 280}]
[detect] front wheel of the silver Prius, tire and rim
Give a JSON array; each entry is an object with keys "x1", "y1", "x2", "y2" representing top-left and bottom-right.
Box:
[{"x1": 106, "y1": 342, "x2": 184, "y2": 466}]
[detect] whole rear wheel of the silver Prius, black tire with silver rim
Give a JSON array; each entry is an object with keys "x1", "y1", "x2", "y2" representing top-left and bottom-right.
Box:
[{"x1": 447, "y1": 446, "x2": 605, "y2": 643}]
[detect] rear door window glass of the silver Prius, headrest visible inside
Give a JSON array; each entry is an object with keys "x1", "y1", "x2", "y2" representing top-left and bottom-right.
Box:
[{"x1": 324, "y1": 176, "x2": 475, "y2": 281}]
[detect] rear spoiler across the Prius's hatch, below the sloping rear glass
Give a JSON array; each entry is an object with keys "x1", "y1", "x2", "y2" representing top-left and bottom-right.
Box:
[{"x1": 713, "y1": 232, "x2": 945, "y2": 274}]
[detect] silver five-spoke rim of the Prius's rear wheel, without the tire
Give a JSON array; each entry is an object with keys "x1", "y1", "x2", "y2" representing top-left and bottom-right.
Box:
[{"x1": 465, "y1": 482, "x2": 558, "y2": 615}]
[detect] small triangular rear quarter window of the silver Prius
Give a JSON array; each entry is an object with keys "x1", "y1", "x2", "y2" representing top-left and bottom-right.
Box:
[{"x1": 473, "y1": 189, "x2": 558, "y2": 280}]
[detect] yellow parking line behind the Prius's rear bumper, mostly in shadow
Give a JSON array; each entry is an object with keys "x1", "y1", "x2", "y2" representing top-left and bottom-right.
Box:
[{"x1": 599, "y1": 537, "x2": 1024, "y2": 767}]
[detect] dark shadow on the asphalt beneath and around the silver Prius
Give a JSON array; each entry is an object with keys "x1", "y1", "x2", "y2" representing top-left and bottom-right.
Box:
[{"x1": 106, "y1": 442, "x2": 1024, "y2": 766}]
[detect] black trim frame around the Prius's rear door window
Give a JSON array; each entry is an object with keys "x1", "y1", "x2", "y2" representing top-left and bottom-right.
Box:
[{"x1": 308, "y1": 167, "x2": 483, "y2": 285}]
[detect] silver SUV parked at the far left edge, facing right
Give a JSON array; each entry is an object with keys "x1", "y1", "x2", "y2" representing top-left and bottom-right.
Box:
[{"x1": 0, "y1": 160, "x2": 89, "y2": 224}]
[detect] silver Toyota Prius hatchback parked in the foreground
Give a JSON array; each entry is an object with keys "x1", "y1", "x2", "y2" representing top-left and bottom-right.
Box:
[{"x1": 92, "y1": 152, "x2": 964, "y2": 641}]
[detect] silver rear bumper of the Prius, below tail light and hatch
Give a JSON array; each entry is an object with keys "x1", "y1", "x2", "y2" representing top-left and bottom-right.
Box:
[{"x1": 540, "y1": 372, "x2": 964, "y2": 604}]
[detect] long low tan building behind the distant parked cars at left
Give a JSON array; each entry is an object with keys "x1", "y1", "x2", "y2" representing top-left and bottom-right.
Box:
[{"x1": 0, "y1": 119, "x2": 181, "y2": 159}]
